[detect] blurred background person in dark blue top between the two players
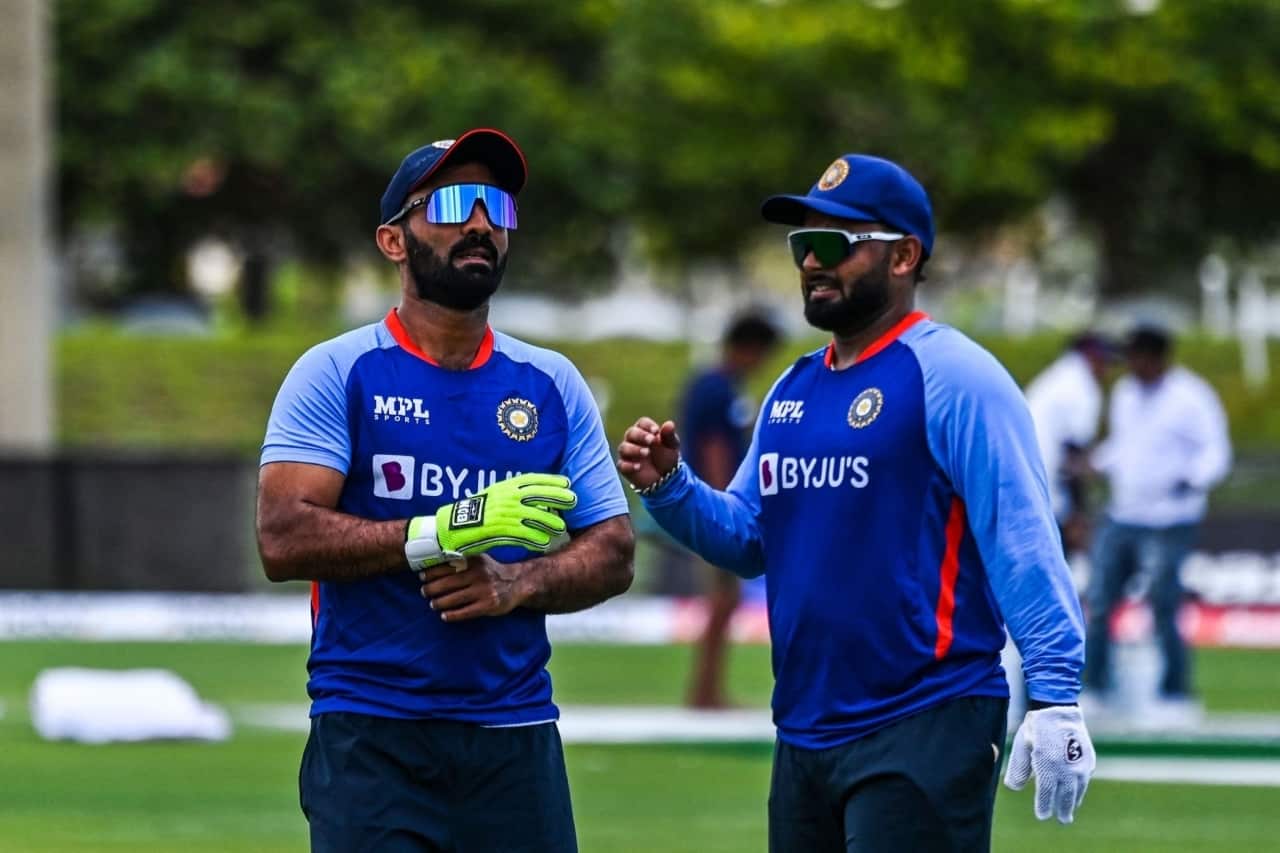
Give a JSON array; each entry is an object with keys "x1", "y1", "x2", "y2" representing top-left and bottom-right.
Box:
[{"x1": 680, "y1": 313, "x2": 780, "y2": 708}]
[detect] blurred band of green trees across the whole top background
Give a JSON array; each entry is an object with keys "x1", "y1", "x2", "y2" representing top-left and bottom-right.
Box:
[{"x1": 58, "y1": 0, "x2": 1280, "y2": 310}]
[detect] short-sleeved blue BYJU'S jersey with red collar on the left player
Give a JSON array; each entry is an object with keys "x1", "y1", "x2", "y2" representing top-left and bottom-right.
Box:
[{"x1": 262, "y1": 310, "x2": 627, "y2": 725}]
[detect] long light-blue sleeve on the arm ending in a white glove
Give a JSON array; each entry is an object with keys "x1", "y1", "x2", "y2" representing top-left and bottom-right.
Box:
[{"x1": 904, "y1": 324, "x2": 1084, "y2": 703}]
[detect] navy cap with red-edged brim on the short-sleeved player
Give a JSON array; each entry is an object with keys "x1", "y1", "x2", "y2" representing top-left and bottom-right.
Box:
[{"x1": 381, "y1": 127, "x2": 529, "y2": 223}]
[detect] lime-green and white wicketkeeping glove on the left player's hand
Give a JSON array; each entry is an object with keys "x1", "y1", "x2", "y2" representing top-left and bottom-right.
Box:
[{"x1": 404, "y1": 474, "x2": 577, "y2": 571}]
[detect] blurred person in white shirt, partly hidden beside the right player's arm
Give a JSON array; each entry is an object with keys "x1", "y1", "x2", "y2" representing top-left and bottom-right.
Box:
[{"x1": 1027, "y1": 332, "x2": 1117, "y2": 552}]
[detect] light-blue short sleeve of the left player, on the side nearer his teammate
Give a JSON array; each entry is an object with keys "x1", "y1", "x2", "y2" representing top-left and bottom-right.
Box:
[{"x1": 493, "y1": 332, "x2": 628, "y2": 530}]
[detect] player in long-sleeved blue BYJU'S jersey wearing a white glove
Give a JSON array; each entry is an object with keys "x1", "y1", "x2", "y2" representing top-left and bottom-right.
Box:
[{"x1": 618, "y1": 154, "x2": 1096, "y2": 853}]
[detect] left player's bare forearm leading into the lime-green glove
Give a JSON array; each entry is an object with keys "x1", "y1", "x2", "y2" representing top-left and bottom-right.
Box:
[{"x1": 257, "y1": 502, "x2": 408, "y2": 581}]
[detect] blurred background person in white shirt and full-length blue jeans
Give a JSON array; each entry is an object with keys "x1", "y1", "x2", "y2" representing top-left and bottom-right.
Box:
[{"x1": 1084, "y1": 325, "x2": 1231, "y2": 722}]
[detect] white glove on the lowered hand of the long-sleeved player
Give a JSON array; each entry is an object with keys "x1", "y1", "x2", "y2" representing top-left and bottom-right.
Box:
[{"x1": 1005, "y1": 704, "x2": 1098, "y2": 824}]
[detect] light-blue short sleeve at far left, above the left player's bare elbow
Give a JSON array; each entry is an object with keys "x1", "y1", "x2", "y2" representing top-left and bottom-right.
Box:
[{"x1": 260, "y1": 323, "x2": 397, "y2": 474}]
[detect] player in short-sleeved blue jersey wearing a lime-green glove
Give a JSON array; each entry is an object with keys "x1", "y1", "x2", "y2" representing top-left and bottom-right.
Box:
[{"x1": 257, "y1": 129, "x2": 634, "y2": 853}]
